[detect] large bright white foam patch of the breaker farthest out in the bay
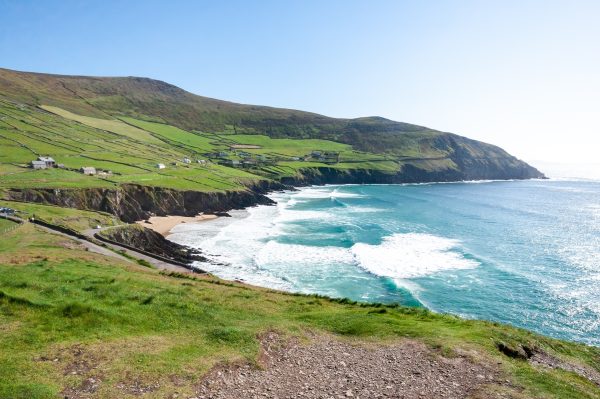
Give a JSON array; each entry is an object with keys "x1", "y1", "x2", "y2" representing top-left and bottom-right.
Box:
[{"x1": 352, "y1": 233, "x2": 479, "y2": 279}]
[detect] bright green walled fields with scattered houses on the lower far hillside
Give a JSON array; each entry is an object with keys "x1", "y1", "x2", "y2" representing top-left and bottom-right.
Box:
[{"x1": 0, "y1": 100, "x2": 418, "y2": 192}]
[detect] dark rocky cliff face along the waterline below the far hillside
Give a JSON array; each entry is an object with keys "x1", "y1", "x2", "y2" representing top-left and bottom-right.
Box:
[{"x1": 4, "y1": 158, "x2": 544, "y2": 222}]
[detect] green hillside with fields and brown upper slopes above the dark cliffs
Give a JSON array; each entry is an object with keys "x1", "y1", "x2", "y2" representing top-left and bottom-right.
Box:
[{"x1": 0, "y1": 69, "x2": 542, "y2": 196}]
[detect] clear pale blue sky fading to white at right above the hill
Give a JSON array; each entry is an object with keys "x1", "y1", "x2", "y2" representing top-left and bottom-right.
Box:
[{"x1": 0, "y1": 0, "x2": 600, "y2": 171}]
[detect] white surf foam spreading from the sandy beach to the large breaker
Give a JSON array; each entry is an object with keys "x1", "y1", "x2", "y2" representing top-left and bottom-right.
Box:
[{"x1": 171, "y1": 187, "x2": 478, "y2": 292}]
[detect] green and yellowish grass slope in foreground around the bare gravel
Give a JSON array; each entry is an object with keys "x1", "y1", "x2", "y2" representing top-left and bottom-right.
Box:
[{"x1": 0, "y1": 224, "x2": 600, "y2": 399}]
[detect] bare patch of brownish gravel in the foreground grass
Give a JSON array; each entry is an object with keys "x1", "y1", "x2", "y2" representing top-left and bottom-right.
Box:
[{"x1": 197, "y1": 334, "x2": 502, "y2": 399}]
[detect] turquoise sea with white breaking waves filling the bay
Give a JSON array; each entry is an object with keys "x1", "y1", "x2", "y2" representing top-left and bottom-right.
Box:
[{"x1": 169, "y1": 181, "x2": 600, "y2": 345}]
